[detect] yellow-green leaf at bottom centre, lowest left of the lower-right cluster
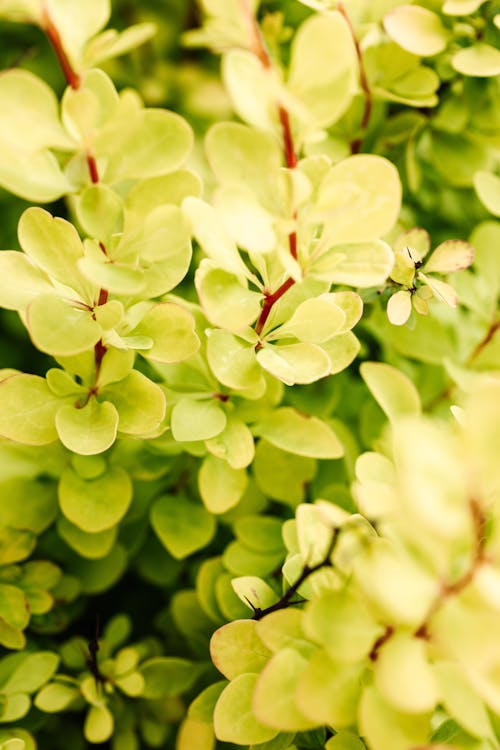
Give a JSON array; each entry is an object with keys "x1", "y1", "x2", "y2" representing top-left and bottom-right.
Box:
[{"x1": 214, "y1": 674, "x2": 277, "y2": 745}]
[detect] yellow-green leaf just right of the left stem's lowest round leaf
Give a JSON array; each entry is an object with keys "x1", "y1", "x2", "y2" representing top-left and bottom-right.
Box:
[{"x1": 100, "y1": 370, "x2": 166, "y2": 435}]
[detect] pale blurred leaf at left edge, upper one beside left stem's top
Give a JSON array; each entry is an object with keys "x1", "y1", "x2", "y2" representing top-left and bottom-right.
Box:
[{"x1": 0, "y1": 68, "x2": 74, "y2": 154}]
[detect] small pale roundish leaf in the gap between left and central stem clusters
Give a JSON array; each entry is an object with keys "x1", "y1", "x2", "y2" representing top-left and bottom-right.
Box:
[{"x1": 171, "y1": 398, "x2": 226, "y2": 442}]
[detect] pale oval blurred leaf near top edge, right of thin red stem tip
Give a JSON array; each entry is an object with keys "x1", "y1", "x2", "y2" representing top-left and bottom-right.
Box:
[{"x1": 384, "y1": 5, "x2": 449, "y2": 57}]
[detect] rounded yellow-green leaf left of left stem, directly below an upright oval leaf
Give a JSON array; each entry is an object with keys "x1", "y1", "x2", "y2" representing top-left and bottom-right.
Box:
[{"x1": 27, "y1": 294, "x2": 102, "y2": 357}]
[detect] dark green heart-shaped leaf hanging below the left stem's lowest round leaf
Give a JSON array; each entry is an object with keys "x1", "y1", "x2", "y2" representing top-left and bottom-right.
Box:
[{"x1": 59, "y1": 466, "x2": 132, "y2": 534}]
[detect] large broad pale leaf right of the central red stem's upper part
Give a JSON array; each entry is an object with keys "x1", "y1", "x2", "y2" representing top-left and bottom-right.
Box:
[{"x1": 310, "y1": 154, "x2": 401, "y2": 250}]
